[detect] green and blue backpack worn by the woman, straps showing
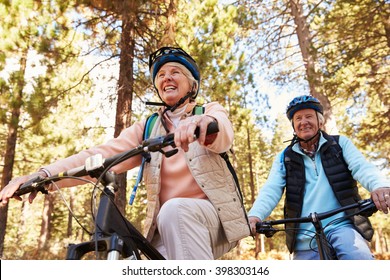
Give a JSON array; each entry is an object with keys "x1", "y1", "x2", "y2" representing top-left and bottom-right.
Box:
[{"x1": 129, "y1": 105, "x2": 243, "y2": 205}]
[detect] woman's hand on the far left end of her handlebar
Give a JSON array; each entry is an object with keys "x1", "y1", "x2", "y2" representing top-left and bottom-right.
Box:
[{"x1": 0, "y1": 171, "x2": 47, "y2": 205}]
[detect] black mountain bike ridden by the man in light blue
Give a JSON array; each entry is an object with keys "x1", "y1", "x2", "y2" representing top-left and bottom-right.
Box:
[{"x1": 256, "y1": 199, "x2": 378, "y2": 260}]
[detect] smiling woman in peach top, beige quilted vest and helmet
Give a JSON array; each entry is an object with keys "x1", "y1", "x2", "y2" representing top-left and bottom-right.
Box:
[{"x1": 0, "y1": 47, "x2": 250, "y2": 259}]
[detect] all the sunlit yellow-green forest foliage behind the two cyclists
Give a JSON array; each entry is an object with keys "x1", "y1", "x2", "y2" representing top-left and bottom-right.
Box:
[{"x1": 0, "y1": 0, "x2": 390, "y2": 259}]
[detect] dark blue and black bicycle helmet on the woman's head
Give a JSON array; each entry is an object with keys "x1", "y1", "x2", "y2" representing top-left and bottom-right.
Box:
[{"x1": 149, "y1": 47, "x2": 200, "y2": 99}]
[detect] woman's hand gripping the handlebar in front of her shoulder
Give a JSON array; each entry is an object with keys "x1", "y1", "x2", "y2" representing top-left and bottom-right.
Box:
[{"x1": 174, "y1": 115, "x2": 216, "y2": 152}]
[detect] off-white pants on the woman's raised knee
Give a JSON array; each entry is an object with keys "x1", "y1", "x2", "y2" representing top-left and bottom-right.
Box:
[{"x1": 152, "y1": 198, "x2": 237, "y2": 260}]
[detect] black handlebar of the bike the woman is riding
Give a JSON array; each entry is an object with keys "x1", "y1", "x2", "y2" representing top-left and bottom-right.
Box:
[{"x1": 14, "y1": 122, "x2": 219, "y2": 196}]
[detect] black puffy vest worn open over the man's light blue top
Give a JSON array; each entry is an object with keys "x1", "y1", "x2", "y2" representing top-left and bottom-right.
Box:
[{"x1": 284, "y1": 131, "x2": 374, "y2": 253}]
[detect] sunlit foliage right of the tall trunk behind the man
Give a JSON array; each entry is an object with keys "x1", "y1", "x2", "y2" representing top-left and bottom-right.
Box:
[{"x1": 316, "y1": 0, "x2": 390, "y2": 167}]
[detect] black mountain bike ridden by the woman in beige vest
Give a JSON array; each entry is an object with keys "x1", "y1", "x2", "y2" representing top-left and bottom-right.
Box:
[{"x1": 14, "y1": 122, "x2": 219, "y2": 260}]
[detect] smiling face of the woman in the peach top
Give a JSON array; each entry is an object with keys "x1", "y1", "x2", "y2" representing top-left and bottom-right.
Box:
[{"x1": 155, "y1": 63, "x2": 191, "y2": 106}]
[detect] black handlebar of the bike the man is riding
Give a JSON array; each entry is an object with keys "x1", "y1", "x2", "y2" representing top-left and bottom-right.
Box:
[{"x1": 256, "y1": 199, "x2": 378, "y2": 237}]
